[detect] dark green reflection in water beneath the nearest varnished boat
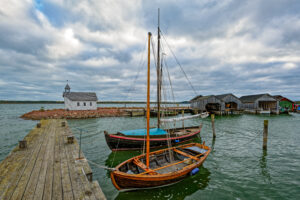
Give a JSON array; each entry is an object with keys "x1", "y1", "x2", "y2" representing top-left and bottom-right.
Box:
[{"x1": 116, "y1": 166, "x2": 211, "y2": 199}]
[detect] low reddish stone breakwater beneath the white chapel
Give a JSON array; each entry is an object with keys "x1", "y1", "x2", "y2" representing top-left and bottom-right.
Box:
[{"x1": 21, "y1": 107, "x2": 144, "y2": 120}]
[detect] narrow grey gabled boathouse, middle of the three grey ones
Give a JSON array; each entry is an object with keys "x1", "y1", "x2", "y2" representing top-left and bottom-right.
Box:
[{"x1": 216, "y1": 93, "x2": 242, "y2": 112}]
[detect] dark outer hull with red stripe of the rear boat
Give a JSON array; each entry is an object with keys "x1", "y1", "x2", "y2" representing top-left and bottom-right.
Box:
[{"x1": 105, "y1": 126, "x2": 202, "y2": 151}]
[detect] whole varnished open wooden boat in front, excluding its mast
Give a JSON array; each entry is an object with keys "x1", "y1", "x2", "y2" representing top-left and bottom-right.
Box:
[{"x1": 111, "y1": 143, "x2": 211, "y2": 190}]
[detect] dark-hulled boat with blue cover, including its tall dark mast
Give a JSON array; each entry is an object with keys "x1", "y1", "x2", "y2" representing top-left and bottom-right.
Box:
[{"x1": 104, "y1": 16, "x2": 208, "y2": 151}]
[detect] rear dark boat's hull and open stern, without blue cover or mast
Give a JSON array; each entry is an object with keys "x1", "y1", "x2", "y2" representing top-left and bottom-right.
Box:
[{"x1": 104, "y1": 125, "x2": 202, "y2": 151}]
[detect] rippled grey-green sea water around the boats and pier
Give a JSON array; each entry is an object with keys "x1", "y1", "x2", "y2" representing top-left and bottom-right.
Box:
[{"x1": 0, "y1": 104, "x2": 300, "y2": 200}]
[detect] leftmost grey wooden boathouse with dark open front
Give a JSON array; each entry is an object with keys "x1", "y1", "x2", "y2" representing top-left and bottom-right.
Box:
[{"x1": 190, "y1": 95, "x2": 225, "y2": 114}]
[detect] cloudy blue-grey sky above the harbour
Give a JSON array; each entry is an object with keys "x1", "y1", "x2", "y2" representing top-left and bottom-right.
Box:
[{"x1": 0, "y1": 0, "x2": 300, "y2": 101}]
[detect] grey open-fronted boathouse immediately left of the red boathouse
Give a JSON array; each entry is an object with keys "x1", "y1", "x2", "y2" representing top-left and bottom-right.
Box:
[{"x1": 240, "y1": 94, "x2": 279, "y2": 114}]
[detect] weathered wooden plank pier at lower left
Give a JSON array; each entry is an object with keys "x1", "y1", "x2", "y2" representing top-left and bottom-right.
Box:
[{"x1": 0, "y1": 119, "x2": 106, "y2": 200}]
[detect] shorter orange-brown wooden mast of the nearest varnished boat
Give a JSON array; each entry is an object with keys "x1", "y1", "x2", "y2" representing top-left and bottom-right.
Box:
[{"x1": 146, "y1": 32, "x2": 151, "y2": 168}]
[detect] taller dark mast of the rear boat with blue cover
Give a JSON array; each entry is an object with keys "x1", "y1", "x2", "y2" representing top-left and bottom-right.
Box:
[{"x1": 156, "y1": 8, "x2": 161, "y2": 128}]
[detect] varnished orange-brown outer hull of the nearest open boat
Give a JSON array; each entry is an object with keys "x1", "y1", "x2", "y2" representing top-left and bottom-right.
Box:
[{"x1": 110, "y1": 143, "x2": 210, "y2": 190}]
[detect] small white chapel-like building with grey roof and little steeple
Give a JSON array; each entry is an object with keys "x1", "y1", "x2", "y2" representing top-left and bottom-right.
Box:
[{"x1": 63, "y1": 84, "x2": 98, "y2": 110}]
